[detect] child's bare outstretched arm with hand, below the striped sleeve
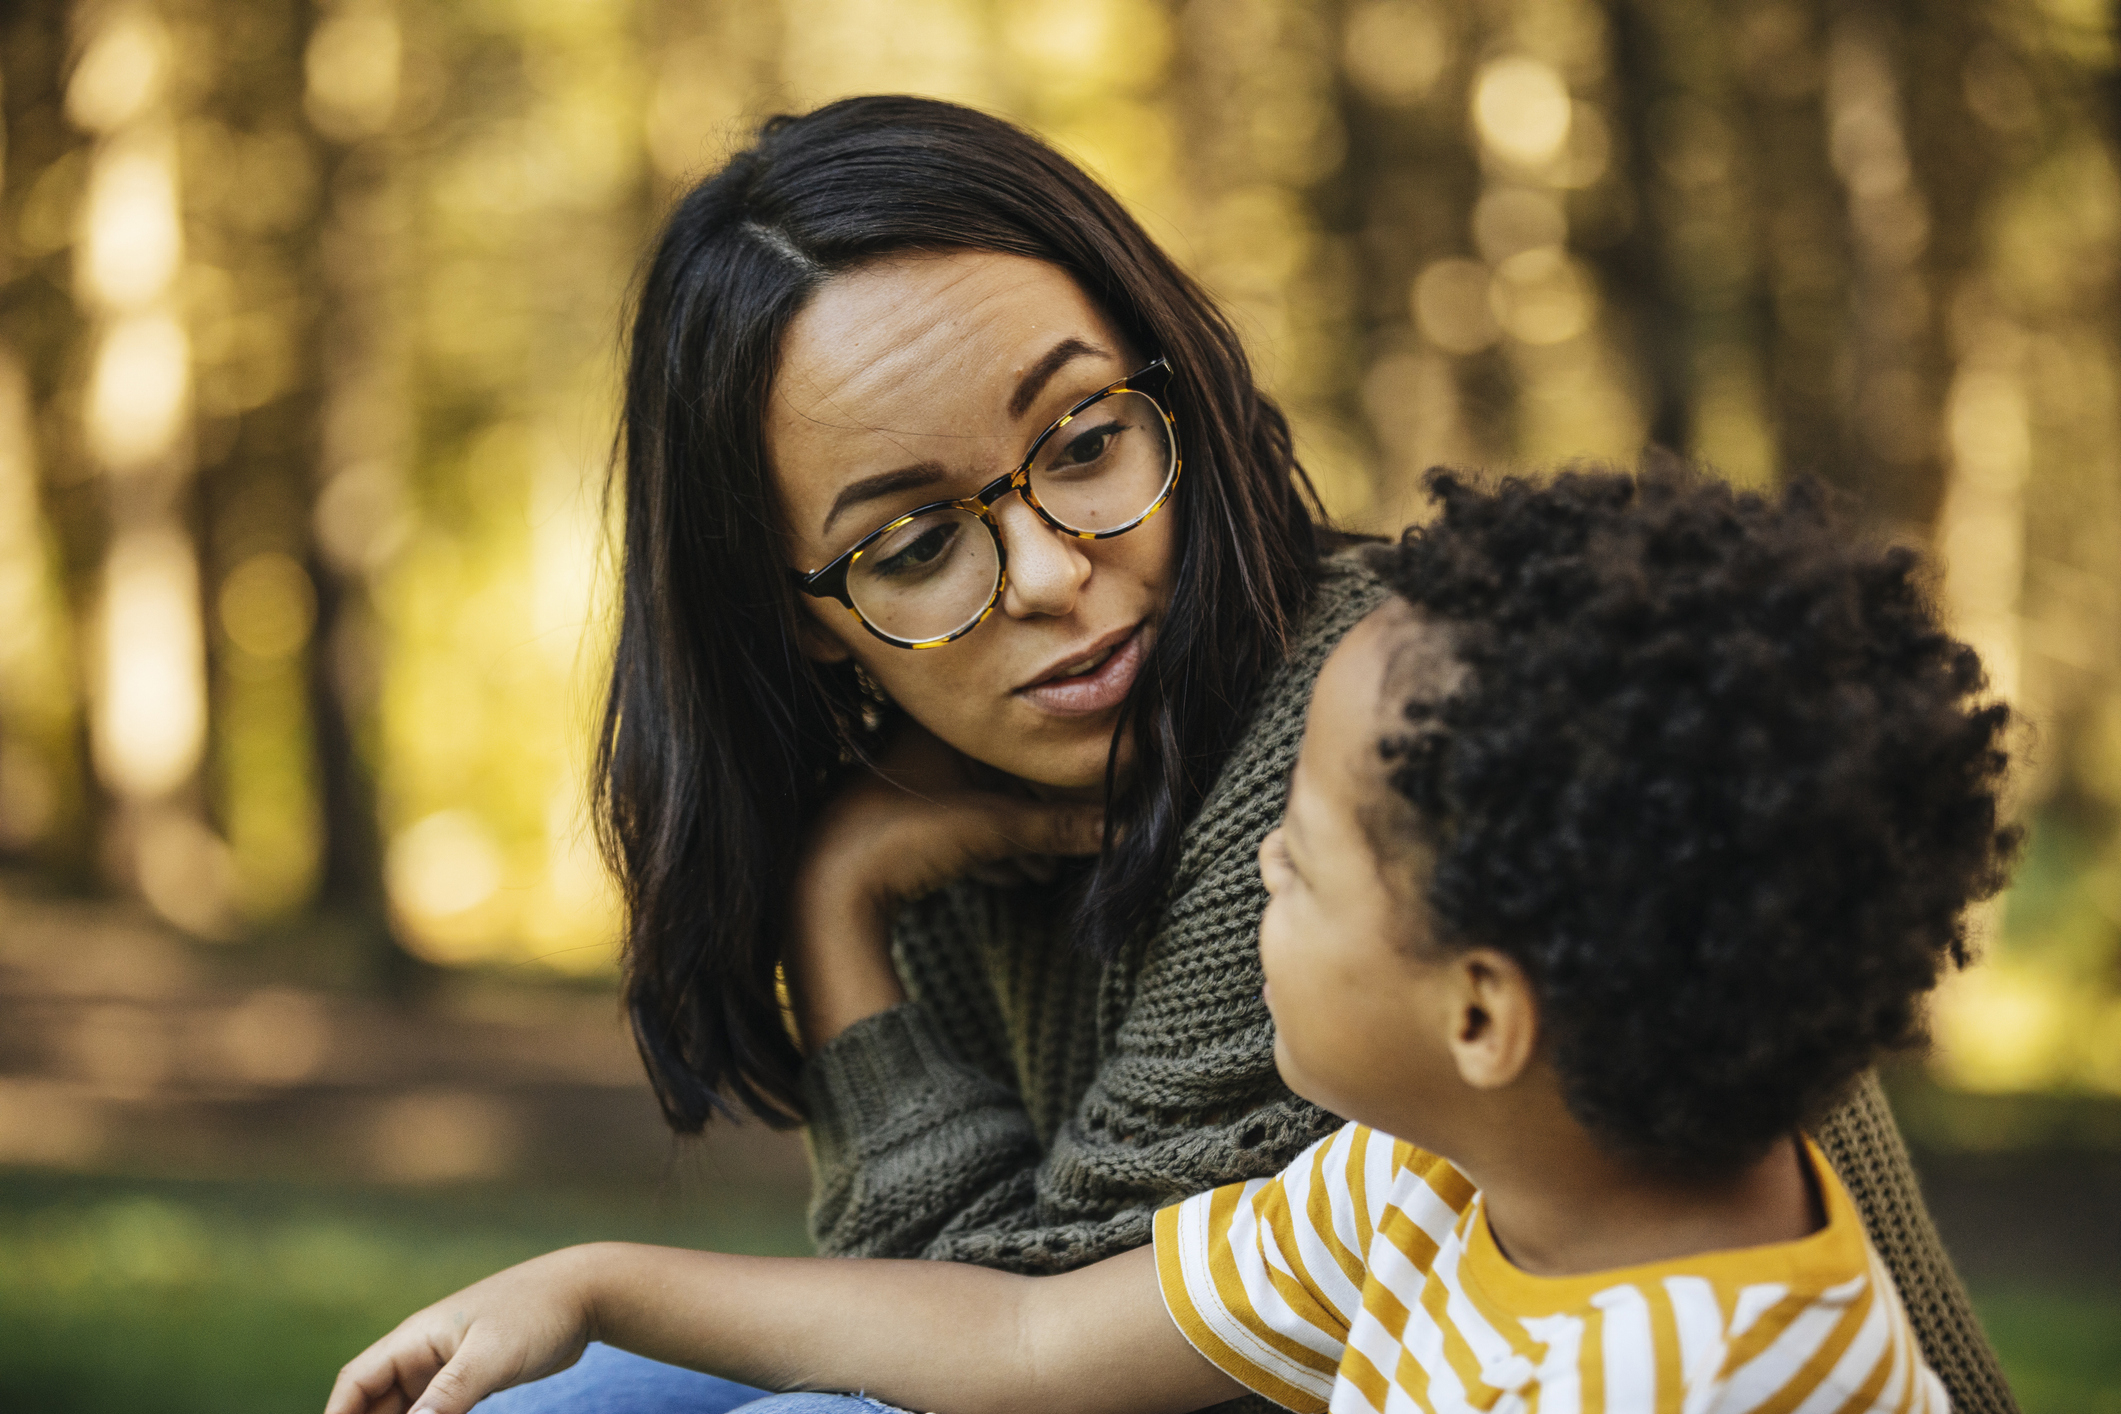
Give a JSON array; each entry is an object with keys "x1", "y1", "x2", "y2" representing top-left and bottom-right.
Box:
[{"x1": 325, "y1": 1242, "x2": 1245, "y2": 1414}]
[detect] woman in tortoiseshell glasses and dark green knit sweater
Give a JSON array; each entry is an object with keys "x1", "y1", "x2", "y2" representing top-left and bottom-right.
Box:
[{"x1": 488, "y1": 98, "x2": 2011, "y2": 1412}]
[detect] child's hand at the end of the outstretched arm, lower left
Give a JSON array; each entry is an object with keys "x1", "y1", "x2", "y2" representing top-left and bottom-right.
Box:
[{"x1": 325, "y1": 1249, "x2": 592, "y2": 1414}]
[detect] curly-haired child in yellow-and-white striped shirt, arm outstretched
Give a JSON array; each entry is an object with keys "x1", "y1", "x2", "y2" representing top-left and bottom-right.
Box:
[{"x1": 327, "y1": 469, "x2": 2013, "y2": 1414}]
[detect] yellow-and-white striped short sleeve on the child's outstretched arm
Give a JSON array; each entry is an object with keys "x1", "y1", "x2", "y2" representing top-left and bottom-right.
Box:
[{"x1": 1156, "y1": 1124, "x2": 1393, "y2": 1414}]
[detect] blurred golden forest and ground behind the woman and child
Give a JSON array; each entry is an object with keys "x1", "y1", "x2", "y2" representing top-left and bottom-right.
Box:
[{"x1": 0, "y1": 0, "x2": 2121, "y2": 1410}]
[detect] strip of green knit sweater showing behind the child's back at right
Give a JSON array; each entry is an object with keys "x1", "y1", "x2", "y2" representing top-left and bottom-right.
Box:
[{"x1": 1818, "y1": 1073, "x2": 2017, "y2": 1414}]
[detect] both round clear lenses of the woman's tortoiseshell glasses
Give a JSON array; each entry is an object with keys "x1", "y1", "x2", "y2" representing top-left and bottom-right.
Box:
[{"x1": 846, "y1": 390, "x2": 1177, "y2": 642}]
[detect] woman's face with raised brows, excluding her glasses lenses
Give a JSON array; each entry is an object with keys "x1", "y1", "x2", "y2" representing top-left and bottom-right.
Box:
[{"x1": 766, "y1": 250, "x2": 1177, "y2": 793}]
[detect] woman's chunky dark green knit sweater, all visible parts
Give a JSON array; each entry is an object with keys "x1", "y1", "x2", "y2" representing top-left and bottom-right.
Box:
[{"x1": 804, "y1": 553, "x2": 2015, "y2": 1414}]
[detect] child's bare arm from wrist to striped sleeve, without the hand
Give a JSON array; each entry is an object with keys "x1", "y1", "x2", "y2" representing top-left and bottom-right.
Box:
[{"x1": 571, "y1": 1242, "x2": 1241, "y2": 1414}]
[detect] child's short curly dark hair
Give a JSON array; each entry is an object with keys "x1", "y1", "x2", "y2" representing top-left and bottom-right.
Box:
[{"x1": 1372, "y1": 464, "x2": 2017, "y2": 1172}]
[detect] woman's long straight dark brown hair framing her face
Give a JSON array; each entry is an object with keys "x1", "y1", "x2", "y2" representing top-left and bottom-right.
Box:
[{"x1": 596, "y1": 98, "x2": 1317, "y2": 1132}]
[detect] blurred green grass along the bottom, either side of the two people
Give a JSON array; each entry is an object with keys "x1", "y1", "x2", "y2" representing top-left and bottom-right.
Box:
[{"x1": 0, "y1": 1174, "x2": 2121, "y2": 1414}]
